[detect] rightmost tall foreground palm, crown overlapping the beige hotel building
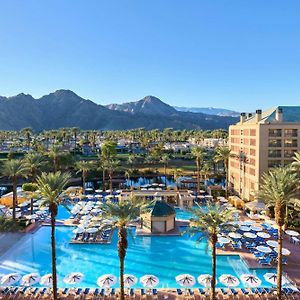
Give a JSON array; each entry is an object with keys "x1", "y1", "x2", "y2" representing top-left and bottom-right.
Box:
[{"x1": 258, "y1": 167, "x2": 300, "y2": 300}]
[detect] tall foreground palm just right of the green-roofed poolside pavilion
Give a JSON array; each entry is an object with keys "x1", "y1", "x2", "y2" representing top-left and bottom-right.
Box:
[{"x1": 188, "y1": 204, "x2": 233, "y2": 300}]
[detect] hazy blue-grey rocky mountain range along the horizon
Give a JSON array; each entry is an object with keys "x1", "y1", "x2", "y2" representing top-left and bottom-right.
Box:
[{"x1": 0, "y1": 90, "x2": 237, "y2": 131}]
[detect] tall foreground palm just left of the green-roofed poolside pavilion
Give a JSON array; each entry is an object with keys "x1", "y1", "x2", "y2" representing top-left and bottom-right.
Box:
[{"x1": 101, "y1": 199, "x2": 148, "y2": 300}]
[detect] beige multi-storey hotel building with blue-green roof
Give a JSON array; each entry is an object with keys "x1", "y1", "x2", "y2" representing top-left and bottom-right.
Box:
[{"x1": 228, "y1": 106, "x2": 300, "y2": 200}]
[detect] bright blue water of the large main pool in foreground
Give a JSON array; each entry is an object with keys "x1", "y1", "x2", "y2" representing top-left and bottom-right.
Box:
[{"x1": 0, "y1": 226, "x2": 274, "y2": 288}]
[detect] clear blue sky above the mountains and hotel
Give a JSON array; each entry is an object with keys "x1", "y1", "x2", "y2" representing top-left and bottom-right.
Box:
[{"x1": 0, "y1": 0, "x2": 300, "y2": 111}]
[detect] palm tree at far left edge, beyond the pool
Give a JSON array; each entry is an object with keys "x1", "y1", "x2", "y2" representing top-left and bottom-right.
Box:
[{"x1": 1, "y1": 159, "x2": 28, "y2": 221}]
